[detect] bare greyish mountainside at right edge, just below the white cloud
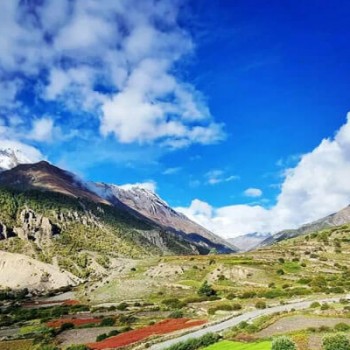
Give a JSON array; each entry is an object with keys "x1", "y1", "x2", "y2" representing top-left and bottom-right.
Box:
[{"x1": 259, "y1": 205, "x2": 350, "y2": 247}]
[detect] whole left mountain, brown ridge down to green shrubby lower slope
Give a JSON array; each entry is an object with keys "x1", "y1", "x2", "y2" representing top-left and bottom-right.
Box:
[{"x1": 0, "y1": 161, "x2": 237, "y2": 286}]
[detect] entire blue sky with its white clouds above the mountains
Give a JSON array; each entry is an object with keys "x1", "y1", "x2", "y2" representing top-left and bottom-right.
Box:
[{"x1": 0, "y1": 0, "x2": 350, "y2": 236}]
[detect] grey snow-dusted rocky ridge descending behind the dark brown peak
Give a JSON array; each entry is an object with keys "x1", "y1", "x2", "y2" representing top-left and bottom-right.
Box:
[{"x1": 94, "y1": 183, "x2": 238, "y2": 253}]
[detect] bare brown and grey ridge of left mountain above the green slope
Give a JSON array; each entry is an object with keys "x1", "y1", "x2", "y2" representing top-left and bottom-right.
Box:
[{"x1": 0, "y1": 161, "x2": 236, "y2": 253}]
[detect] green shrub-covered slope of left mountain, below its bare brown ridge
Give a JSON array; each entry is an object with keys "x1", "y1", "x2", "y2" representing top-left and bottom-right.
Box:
[{"x1": 0, "y1": 188, "x2": 196, "y2": 277}]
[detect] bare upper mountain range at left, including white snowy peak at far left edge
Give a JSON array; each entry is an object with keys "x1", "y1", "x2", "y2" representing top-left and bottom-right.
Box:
[{"x1": 0, "y1": 149, "x2": 238, "y2": 253}]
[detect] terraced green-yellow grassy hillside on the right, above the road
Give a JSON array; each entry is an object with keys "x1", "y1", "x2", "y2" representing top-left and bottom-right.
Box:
[{"x1": 87, "y1": 226, "x2": 350, "y2": 309}]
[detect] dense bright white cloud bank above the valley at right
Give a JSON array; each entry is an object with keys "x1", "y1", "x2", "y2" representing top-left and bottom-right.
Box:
[{"x1": 177, "y1": 114, "x2": 350, "y2": 237}]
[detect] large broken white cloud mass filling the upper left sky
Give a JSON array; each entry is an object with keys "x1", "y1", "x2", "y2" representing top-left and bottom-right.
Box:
[{"x1": 0, "y1": 0, "x2": 225, "y2": 148}]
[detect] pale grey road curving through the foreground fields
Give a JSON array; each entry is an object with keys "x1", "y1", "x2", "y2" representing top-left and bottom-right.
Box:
[{"x1": 149, "y1": 296, "x2": 348, "y2": 350}]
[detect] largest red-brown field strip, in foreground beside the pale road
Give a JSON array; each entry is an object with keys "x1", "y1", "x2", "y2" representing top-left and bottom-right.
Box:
[{"x1": 88, "y1": 318, "x2": 206, "y2": 350}]
